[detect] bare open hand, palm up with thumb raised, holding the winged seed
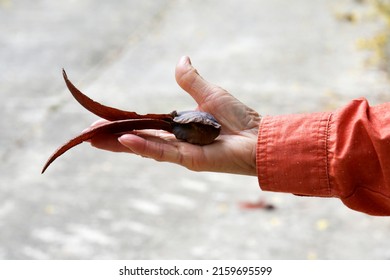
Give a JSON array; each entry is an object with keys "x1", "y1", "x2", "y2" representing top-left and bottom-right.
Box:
[{"x1": 90, "y1": 56, "x2": 261, "y2": 176}]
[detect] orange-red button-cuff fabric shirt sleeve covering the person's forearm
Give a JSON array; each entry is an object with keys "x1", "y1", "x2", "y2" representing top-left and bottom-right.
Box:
[{"x1": 256, "y1": 99, "x2": 390, "y2": 215}]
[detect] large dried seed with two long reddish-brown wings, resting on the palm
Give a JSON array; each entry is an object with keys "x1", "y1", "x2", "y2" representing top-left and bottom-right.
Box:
[{"x1": 42, "y1": 70, "x2": 221, "y2": 173}]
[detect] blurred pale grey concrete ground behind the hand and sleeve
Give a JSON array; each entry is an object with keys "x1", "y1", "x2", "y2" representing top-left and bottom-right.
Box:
[{"x1": 0, "y1": 0, "x2": 390, "y2": 259}]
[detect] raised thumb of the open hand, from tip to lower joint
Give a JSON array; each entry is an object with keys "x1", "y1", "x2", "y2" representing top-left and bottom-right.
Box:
[{"x1": 175, "y1": 56, "x2": 215, "y2": 106}]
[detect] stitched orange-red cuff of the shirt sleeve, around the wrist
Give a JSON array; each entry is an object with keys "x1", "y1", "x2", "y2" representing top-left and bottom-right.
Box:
[{"x1": 256, "y1": 113, "x2": 332, "y2": 197}]
